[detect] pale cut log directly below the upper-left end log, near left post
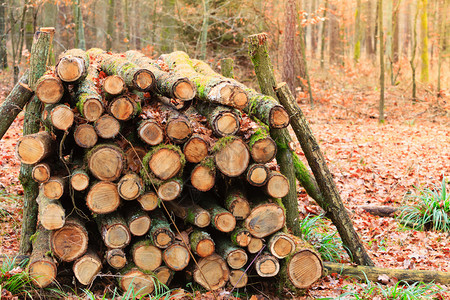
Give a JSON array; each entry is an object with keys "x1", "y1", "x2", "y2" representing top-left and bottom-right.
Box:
[{"x1": 42, "y1": 104, "x2": 75, "y2": 131}]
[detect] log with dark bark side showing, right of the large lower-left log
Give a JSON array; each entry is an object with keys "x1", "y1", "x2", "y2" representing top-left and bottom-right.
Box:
[{"x1": 95, "y1": 212, "x2": 131, "y2": 249}]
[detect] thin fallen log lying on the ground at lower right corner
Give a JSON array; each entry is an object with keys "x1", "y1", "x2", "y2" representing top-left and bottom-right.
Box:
[{"x1": 323, "y1": 262, "x2": 450, "y2": 285}]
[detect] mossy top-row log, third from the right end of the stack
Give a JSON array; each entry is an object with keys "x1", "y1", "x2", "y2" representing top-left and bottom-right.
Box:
[{"x1": 125, "y1": 50, "x2": 196, "y2": 101}]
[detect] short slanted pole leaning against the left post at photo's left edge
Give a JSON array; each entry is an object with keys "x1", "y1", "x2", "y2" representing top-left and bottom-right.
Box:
[{"x1": 0, "y1": 70, "x2": 33, "y2": 140}]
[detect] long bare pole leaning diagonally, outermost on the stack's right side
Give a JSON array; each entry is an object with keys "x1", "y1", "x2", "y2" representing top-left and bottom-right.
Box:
[{"x1": 277, "y1": 83, "x2": 373, "y2": 266}]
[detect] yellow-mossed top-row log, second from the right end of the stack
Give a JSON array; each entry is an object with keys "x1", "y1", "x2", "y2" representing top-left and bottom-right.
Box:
[{"x1": 161, "y1": 51, "x2": 248, "y2": 109}]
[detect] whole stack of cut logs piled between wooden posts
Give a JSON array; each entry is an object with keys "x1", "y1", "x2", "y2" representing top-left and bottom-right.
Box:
[{"x1": 16, "y1": 49, "x2": 322, "y2": 294}]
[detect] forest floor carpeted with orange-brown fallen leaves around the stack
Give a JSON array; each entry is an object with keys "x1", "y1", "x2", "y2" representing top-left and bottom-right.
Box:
[{"x1": 0, "y1": 62, "x2": 450, "y2": 299}]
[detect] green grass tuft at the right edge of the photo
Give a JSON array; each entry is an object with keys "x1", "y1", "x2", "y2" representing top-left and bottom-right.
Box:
[{"x1": 398, "y1": 177, "x2": 450, "y2": 231}]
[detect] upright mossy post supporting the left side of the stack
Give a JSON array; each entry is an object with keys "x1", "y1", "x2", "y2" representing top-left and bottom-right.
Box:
[{"x1": 19, "y1": 29, "x2": 55, "y2": 254}]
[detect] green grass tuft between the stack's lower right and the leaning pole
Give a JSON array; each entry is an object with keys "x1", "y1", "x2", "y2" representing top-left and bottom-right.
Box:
[{"x1": 300, "y1": 215, "x2": 346, "y2": 261}]
